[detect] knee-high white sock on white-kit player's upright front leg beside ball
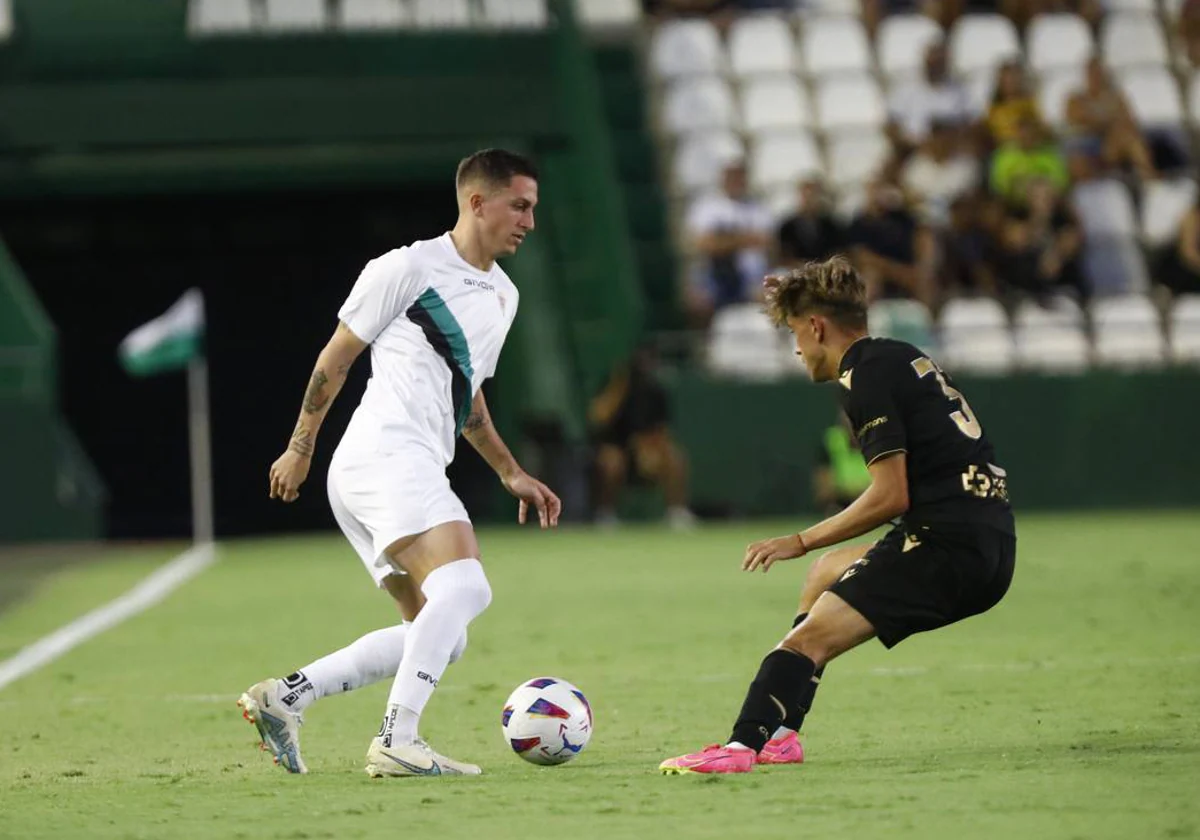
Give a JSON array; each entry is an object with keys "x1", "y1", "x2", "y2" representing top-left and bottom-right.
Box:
[{"x1": 379, "y1": 559, "x2": 492, "y2": 746}]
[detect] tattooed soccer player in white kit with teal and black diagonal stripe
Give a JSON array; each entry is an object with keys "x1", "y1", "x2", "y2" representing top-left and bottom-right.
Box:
[{"x1": 238, "y1": 149, "x2": 562, "y2": 776}]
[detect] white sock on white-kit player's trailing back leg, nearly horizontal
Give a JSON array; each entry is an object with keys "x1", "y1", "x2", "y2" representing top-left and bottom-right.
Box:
[{"x1": 280, "y1": 622, "x2": 467, "y2": 712}]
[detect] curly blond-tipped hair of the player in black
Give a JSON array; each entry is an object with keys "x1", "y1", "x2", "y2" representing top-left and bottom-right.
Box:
[{"x1": 766, "y1": 256, "x2": 866, "y2": 328}]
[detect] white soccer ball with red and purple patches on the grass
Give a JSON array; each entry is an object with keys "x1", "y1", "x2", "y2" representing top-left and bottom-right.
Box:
[{"x1": 500, "y1": 677, "x2": 592, "y2": 764}]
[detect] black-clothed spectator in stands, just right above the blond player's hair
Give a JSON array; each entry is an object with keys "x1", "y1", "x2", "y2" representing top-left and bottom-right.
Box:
[{"x1": 846, "y1": 178, "x2": 936, "y2": 307}]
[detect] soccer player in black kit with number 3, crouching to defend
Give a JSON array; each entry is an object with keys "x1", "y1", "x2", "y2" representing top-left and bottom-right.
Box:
[{"x1": 660, "y1": 257, "x2": 1016, "y2": 774}]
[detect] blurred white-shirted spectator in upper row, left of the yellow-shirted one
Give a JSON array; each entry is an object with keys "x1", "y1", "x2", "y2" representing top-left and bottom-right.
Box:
[{"x1": 888, "y1": 42, "x2": 978, "y2": 156}]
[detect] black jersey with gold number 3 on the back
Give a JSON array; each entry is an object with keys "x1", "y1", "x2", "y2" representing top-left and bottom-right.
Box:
[{"x1": 838, "y1": 337, "x2": 1015, "y2": 533}]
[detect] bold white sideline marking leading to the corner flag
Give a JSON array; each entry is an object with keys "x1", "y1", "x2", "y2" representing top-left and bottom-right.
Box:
[{"x1": 0, "y1": 542, "x2": 216, "y2": 690}]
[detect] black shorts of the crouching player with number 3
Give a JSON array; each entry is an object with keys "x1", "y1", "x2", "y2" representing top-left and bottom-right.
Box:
[{"x1": 829, "y1": 523, "x2": 1016, "y2": 648}]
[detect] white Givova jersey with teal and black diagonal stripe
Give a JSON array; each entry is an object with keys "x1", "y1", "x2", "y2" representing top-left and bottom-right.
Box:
[{"x1": 337, "y1": 233, "x2": 517, "y2": 467}]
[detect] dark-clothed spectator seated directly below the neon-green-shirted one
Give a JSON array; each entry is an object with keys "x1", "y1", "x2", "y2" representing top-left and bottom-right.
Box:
[{"x1": 1001, "y1": 178, "x2": 1087, "y2": 300}]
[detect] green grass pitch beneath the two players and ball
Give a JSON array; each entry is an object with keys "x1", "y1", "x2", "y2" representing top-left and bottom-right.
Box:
[{"x1": 0, "y1": 511, "x2": 1200, "y2": 840}]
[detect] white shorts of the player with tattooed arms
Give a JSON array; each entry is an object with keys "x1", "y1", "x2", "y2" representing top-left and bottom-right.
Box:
[{"x1": 328, "y1": 416, "x2": 470, "y2": 586}]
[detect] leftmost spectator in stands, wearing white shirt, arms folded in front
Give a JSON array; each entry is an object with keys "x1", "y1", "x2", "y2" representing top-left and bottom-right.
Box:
[{"x1": 685, "y1": 162, "x2": 774, "y2": 326}]
